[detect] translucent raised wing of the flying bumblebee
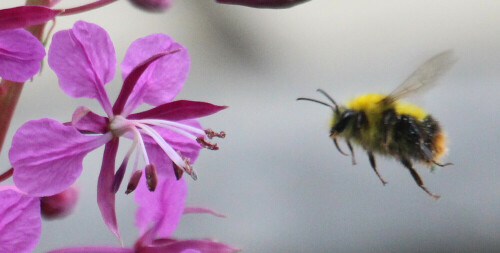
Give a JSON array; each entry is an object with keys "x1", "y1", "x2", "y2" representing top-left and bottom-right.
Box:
[{"x1": 382, "y1": 50, "x2": 457, "y2": 104}]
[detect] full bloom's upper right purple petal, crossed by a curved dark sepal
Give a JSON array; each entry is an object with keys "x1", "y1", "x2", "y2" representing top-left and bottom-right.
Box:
[{"x1": 121, "y1": 34, "x2": 190, "y2": 111}]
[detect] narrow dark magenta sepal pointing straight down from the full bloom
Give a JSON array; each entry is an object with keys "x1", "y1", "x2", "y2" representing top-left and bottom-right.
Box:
[{"x1": 97, "y1": 138, "x2": 121, "y2": 240}]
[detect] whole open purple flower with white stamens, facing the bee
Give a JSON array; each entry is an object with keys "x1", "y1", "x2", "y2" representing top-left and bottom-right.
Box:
[{"x1": 9, "y1": 21, "x2": 226, "y2": 237}]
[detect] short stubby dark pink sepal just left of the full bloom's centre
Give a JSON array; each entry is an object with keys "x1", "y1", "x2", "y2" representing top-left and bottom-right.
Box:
[{"x1": 71, "y1": 106, "x2": 109, "y2": 133}]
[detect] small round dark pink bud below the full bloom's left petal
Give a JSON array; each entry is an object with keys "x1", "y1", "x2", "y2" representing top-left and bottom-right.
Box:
[{"x1": 40, "y1": 186, "x2": 79, "y2": 219}]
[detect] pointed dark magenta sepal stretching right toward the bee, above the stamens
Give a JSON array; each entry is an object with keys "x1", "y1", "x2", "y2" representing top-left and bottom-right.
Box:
[{"x1": 127, "y1": 100, "x2": 227, "y2": 121}]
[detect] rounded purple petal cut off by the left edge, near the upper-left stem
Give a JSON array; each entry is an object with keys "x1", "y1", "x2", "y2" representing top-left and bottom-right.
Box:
[{"x1": 0, "y1": 28, "x2": 45, "y2": 82}]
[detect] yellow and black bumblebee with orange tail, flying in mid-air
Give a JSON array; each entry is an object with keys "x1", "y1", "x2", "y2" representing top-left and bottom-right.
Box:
[{"x1": 297, "y1": 51, "x2": 455, "y2": 199}]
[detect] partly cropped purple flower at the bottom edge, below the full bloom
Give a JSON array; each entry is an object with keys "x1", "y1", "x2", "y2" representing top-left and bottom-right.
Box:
[{"x1": 49, "y1": 176, "x2": 239, "y2": 253}]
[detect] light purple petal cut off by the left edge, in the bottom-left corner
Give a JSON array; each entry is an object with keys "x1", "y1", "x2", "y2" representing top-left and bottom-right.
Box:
[{"x1": 0, "y1": 186, "x2": 42, "y2": 253}]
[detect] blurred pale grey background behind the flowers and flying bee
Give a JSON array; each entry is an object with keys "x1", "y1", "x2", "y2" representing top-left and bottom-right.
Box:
[{"x1": 0, "y1": 0, "x2": 500, "y2": 253}]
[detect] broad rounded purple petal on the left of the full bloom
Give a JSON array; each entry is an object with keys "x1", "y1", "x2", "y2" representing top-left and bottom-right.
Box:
[{"x1": 9, "y1": 118, "x2": 111, "y2": 197}]
